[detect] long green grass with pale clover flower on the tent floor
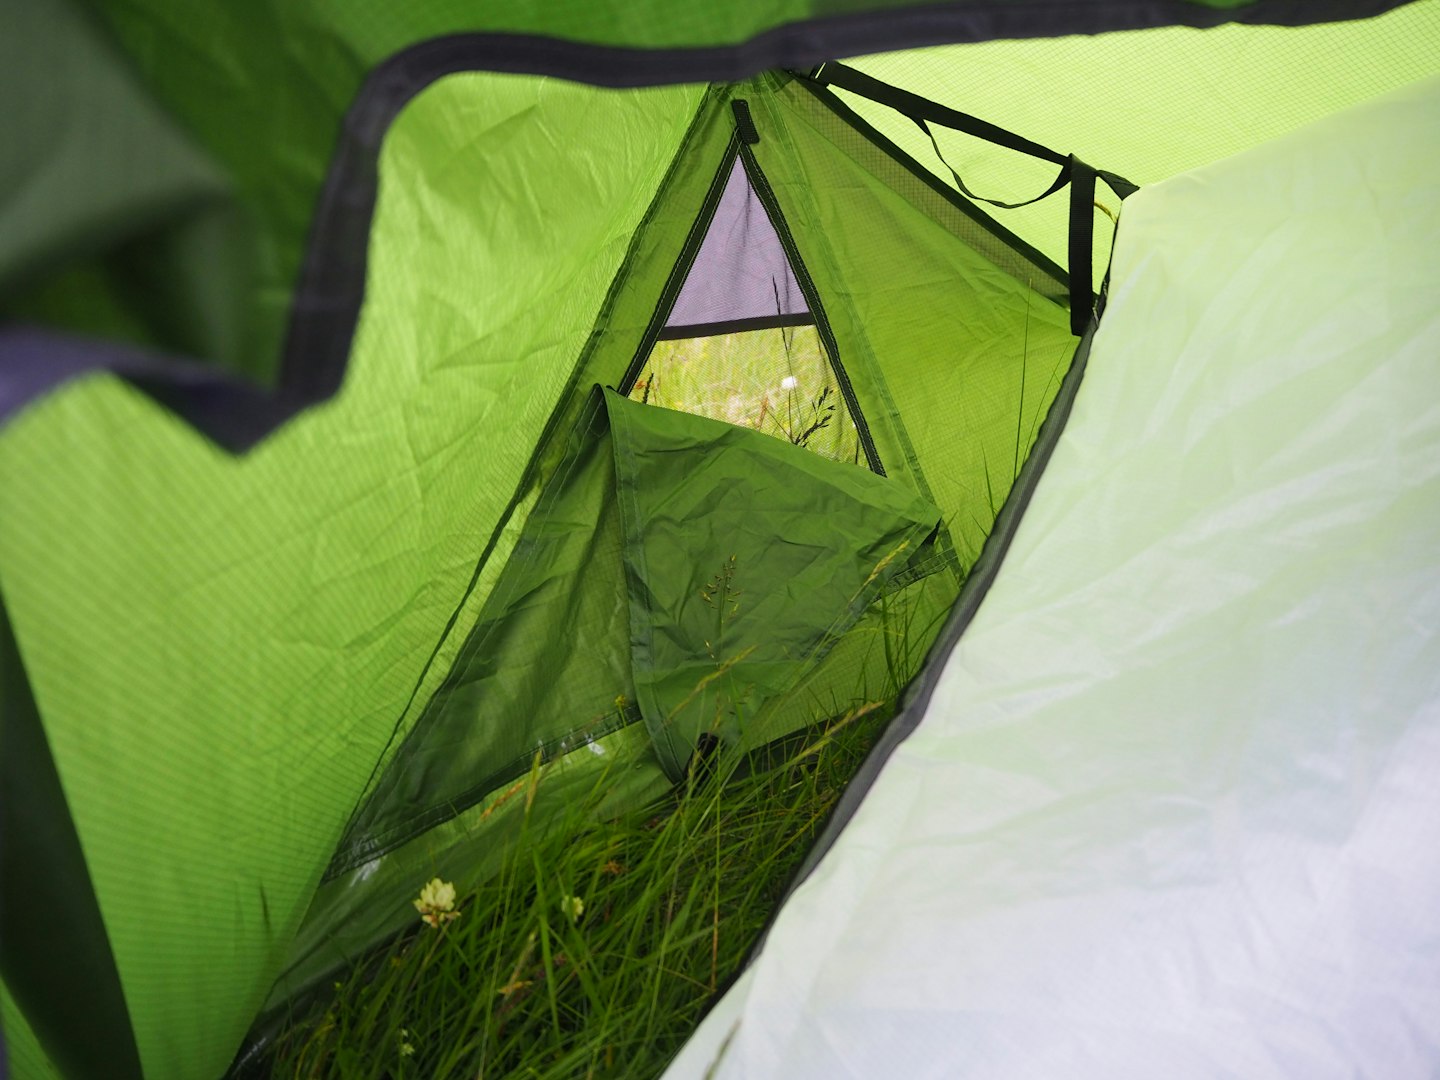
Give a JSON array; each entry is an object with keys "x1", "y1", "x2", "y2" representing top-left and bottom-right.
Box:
[{"x1": 269, "y1": 703, "x2": 893, "y2": 1080}]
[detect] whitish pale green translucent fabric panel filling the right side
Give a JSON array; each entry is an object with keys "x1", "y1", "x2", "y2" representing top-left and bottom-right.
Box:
[{"x1": 672, "y1": 79, "x2": 1440, "y2": 1080}]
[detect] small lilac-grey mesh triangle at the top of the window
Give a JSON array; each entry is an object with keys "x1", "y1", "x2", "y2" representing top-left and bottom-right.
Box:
[{"x1": 665, "y1": 158, "x2": 809, "y2": 327}]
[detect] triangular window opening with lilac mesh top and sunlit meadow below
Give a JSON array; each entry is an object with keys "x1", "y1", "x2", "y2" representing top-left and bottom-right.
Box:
[{"x1": 629, "y1": 157, "x2": 865, "y2": 464}]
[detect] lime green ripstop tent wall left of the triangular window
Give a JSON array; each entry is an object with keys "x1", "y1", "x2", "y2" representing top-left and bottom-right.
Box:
[{"x1": 0, "y1": 75, "x2": 698, "y2": 1077}]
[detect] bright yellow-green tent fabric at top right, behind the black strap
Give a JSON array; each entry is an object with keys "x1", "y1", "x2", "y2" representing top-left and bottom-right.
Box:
[{"x1": 841, "y1": 0, "x2": 1440, "y2": 270}]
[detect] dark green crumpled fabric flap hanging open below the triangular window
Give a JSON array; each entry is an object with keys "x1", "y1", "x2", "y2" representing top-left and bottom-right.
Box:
[{"x1": 606, "y1": 390, "x2": 940, "y2": 778}]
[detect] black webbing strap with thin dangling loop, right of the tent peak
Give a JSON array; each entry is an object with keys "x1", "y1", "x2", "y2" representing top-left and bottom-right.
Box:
[{"x1": 809, "y1": 63, "x2": 1139, "y2": 336}]
